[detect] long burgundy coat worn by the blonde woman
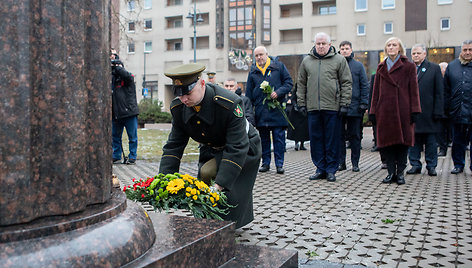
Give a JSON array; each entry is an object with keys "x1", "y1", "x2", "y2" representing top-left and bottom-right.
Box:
[{"x1": 369, "y1": 56, "x2": 421, "y2": 148}]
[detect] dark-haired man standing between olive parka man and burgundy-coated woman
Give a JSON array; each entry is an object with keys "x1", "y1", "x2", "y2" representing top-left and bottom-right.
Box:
[{"x1": 338, "y1": 41, "x2": 369, "y2": 172}]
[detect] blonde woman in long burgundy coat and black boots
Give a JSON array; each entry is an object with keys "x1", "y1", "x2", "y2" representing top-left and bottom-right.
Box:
[{"x1": 369, "y1": 37, "x2": 421, "y2": 184}]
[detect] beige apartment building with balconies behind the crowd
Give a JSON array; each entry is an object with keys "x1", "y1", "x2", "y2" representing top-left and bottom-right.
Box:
[{"x1": 117, "y1": 0, "x2": 472, "y2": 109}]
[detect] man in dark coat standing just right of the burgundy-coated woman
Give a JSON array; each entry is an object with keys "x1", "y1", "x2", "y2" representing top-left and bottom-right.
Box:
[{"x1": 407, "y1": 44, "x2": 444, "y2": 176}]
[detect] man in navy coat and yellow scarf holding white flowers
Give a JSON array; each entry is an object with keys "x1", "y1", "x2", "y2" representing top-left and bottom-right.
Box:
[{"x1": 246, "y1": 46, "x2": 293, "y2": 174}]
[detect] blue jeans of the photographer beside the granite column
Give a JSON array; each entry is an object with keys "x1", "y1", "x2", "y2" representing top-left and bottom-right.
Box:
[{"x1": 112, "y1": 115, "x2": 138, "y2": 159}]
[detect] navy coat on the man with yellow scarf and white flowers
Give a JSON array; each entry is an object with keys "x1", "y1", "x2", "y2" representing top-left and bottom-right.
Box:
[{"x1": 246, "y1": 57, "x2": 293, "y2": 127}]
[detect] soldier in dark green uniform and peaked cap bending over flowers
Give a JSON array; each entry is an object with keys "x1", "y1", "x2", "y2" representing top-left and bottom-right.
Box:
[{"x1": 159, "y1": 63, "x2": 261, "y2": 228}]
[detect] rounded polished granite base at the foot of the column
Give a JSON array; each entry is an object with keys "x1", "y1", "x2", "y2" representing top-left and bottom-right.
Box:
[{"x1": 0, "y1": 189, "x2": 155, "y2": 267}]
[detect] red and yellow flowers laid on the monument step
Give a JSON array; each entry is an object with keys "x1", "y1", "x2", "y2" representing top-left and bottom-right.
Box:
[{"x1": 123, "y1": 173, "x2": 233, "y2": 220}]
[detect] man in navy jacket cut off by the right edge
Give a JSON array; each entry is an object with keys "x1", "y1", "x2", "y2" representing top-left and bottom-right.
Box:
[{"x1": 444, "y1": 40, "x2": 472, "y2": 174}]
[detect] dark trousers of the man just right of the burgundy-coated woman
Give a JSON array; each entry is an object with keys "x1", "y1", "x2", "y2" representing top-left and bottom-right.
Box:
[{"x1": 408, "y1": 133, "x2": 438, "y2": 168}]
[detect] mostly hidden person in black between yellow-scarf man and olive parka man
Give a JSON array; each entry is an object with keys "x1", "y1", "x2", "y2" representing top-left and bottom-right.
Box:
[{"x1": 287, "y1": 83, "x2": 310, "y2": 151}]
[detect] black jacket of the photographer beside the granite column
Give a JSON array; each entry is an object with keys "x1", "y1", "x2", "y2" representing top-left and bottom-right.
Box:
[{"x1": 111, "y1": 66, "x2": 139, "y2": 120}]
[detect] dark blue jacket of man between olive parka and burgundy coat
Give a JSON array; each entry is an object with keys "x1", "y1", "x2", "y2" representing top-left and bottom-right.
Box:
[{"x1": 346, "y1": 54, "x2": 369, "y2": 117}]
